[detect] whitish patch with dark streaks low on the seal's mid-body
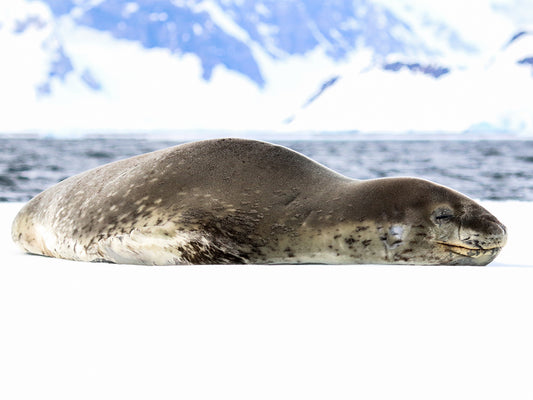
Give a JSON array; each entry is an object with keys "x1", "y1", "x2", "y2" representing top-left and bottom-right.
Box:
[{"x1": 94, "y1": 226, "x2": 248, "y2": 265}]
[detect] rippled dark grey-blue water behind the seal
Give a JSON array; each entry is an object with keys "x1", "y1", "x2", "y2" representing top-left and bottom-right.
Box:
[{"x1": 0, "y1": 137, "x2": 533, "y2": 201}]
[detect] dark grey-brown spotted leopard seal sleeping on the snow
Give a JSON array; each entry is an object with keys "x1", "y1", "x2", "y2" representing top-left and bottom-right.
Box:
[{"x1": 12, "y1": 139, "x2": 507, "y2": 265}]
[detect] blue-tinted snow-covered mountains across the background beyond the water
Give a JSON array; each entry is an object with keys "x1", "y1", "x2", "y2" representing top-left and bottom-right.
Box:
[{"x1": 0, "y1": 0, "x2": 533, "y2": 134}]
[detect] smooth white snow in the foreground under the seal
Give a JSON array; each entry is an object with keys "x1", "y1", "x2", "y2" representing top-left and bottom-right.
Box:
[{"x1": 0, "y1": 202, "x2": 533, "y2": 400}]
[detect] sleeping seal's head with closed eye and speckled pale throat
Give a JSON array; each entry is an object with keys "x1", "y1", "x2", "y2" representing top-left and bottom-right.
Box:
[{"x1": 324, "y1": 178, "x2": 507, "y2": 265}]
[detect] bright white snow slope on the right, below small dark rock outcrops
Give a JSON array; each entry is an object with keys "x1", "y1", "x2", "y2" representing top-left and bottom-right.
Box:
[{"x1": 284, "y1": 46, "x2": 533, "y2": 133}]
